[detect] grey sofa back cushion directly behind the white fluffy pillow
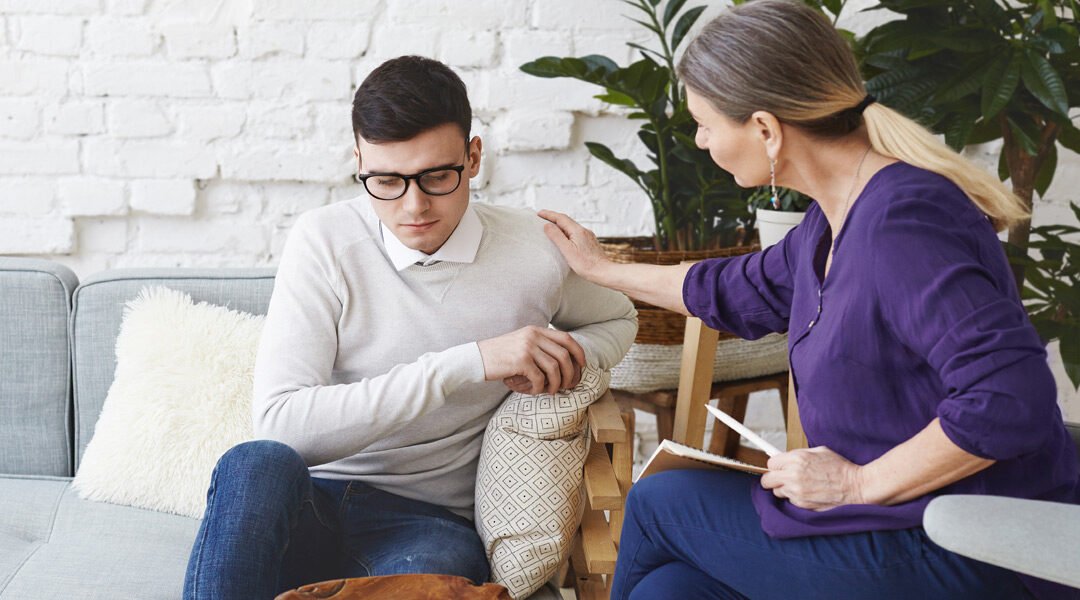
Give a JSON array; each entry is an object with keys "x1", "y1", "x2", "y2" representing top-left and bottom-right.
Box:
[{"x1": 71, "y1": 269, "x2": 274, "y2": 469}]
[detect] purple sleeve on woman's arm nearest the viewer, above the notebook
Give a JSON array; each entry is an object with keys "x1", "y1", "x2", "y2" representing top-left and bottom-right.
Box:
[{"x1": 873, "y1": 190, "x2": 1059, "y2": 460}]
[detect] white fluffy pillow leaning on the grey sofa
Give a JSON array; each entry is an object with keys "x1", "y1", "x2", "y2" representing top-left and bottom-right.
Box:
[{"x1": 73, "y1": 287, "x2": 264, "y2": 518}]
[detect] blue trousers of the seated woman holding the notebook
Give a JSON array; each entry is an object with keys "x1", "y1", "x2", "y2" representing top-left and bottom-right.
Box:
[{"x1": 611, "y1": 471, "x2": 1027, "y2": 600}]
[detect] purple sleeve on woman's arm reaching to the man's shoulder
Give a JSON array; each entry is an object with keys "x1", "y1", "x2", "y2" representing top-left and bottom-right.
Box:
[{"x1": 683, "y1": 221, "x2": 809, "y2": 340}]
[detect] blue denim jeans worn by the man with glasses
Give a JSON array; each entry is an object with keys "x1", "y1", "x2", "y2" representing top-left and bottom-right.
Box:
[{"x1": 184, "y1": 440, "x2": 489, "y2": 600}]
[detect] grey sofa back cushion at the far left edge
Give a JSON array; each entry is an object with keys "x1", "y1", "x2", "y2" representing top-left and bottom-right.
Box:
[{"x1": 0, "y1": 258, "x2": 78, "y2": 476}]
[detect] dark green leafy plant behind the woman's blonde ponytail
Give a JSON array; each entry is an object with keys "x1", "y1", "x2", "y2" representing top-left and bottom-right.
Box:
[{"x1": 842, "y1": 0, "x2": 1080, "y2": 387}]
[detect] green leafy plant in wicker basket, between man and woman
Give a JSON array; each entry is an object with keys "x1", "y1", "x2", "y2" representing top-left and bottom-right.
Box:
[{"x1": 521, "y1": 0, "x2": 754, "y2": 250}]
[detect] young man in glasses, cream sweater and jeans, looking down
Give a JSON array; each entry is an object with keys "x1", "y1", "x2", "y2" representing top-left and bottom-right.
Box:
[{"x1": 185, "y1": 56, "x2": 637, "y2": 600}]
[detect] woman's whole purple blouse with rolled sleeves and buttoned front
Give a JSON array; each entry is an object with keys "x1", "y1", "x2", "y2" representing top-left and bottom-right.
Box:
[{"x1": 683, "y1": 163, "x2": 1080, "y2": 537}]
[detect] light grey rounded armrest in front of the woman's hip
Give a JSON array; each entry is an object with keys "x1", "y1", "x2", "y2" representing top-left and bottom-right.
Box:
[{"x1": 922, "y1": 494, "x2": 1080, "y2": 587}]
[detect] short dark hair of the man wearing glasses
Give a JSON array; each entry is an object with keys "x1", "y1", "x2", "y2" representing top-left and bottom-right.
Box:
[{"x1": 352, "y1": 56, "x2": 472, "y2": 144}]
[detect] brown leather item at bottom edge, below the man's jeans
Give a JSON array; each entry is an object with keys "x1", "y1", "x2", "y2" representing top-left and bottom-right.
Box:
[{"x1": 275, "y1": 574, "x2": 511, "y2": 600}]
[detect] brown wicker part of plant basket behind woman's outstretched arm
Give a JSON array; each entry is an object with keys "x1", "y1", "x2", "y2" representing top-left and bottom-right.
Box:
[{"x1": 599, "y1": 237, "x2": 760, "y2": 345}]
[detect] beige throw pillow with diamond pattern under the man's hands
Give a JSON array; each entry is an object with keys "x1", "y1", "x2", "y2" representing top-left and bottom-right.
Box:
[{"x1": 476, "y1": 367, "x2": 610, "y2": 599}]
